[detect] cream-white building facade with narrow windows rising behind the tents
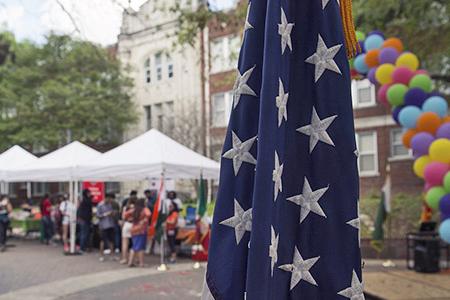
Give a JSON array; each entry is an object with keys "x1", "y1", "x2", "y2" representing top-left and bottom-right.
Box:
[{"x1": 118, "y1": 0, "x2": 207, "y2": 142}]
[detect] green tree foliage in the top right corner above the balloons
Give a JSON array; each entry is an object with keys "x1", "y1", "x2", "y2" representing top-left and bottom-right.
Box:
[{"x1": 353, "y1": 0, "x2": 450, "y2": 90}]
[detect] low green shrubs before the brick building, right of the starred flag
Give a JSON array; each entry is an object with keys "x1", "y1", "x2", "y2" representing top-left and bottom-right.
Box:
[{"x1": 360, "y1": 194, "x2": 423, "y2": 239}]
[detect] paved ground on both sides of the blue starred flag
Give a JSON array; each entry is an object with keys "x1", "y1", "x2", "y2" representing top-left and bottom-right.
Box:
[{"x1": 0, "y1": 240, "x2": 450, "y2": 300}]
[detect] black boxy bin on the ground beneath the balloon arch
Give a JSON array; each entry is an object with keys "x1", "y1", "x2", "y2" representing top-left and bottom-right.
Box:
[{"x1": 408, "y1": 232, "x2": 441, "y2": 273}]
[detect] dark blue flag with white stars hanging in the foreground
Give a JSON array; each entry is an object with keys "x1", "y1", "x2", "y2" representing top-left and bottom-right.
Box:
[{"x1": 204, "y1": 0, "x2": 364, "y2": 300}]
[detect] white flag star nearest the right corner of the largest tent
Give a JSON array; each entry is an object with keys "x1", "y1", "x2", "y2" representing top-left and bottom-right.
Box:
[{"x1": 222, "y1": 131, "x2": 256, "y2": 176}]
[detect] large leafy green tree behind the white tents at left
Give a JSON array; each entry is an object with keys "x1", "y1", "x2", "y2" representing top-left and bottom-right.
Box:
[{"x1": 0, "y1": 34, "x2": 134, "y2": 150}]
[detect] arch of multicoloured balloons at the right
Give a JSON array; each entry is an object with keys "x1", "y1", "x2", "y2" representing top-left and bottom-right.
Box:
[{"x1": 350, "y1": 31, "x2": 450, "y2": 243}]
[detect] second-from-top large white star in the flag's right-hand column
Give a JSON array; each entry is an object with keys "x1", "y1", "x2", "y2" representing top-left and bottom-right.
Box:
[{"x1": 297, "y1": 106, "x2": 337, "y2": 153}]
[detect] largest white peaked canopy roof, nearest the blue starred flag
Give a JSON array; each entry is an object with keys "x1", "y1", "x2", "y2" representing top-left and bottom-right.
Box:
[{"x1": 77, "y1": 129, "x2": 220, "y2": 181}]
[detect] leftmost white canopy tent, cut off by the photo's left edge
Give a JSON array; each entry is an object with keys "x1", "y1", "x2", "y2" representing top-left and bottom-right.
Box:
[{"x1": 0, "y1": 145, "x2": 38, "y2": 194}]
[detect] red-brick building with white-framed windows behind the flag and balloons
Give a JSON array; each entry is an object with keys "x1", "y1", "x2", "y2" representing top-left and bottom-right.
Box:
[{"x1": 209, "y1": 11, "x2": 423, "y2": 197}]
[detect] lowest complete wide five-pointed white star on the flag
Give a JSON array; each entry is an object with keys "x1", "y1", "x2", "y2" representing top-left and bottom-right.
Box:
[{"x1": 278, "y1": 247, "x2": 320, "y2": 290}]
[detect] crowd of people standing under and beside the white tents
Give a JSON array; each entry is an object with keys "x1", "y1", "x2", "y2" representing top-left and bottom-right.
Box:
[{"x1": 0, "y1": 189, "x2": 182, "y2": 267}]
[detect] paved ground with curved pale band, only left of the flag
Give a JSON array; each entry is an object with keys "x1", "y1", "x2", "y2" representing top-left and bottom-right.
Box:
[{"x1": 0, "y1": 240, "x2": 204, "y2": 300}]
